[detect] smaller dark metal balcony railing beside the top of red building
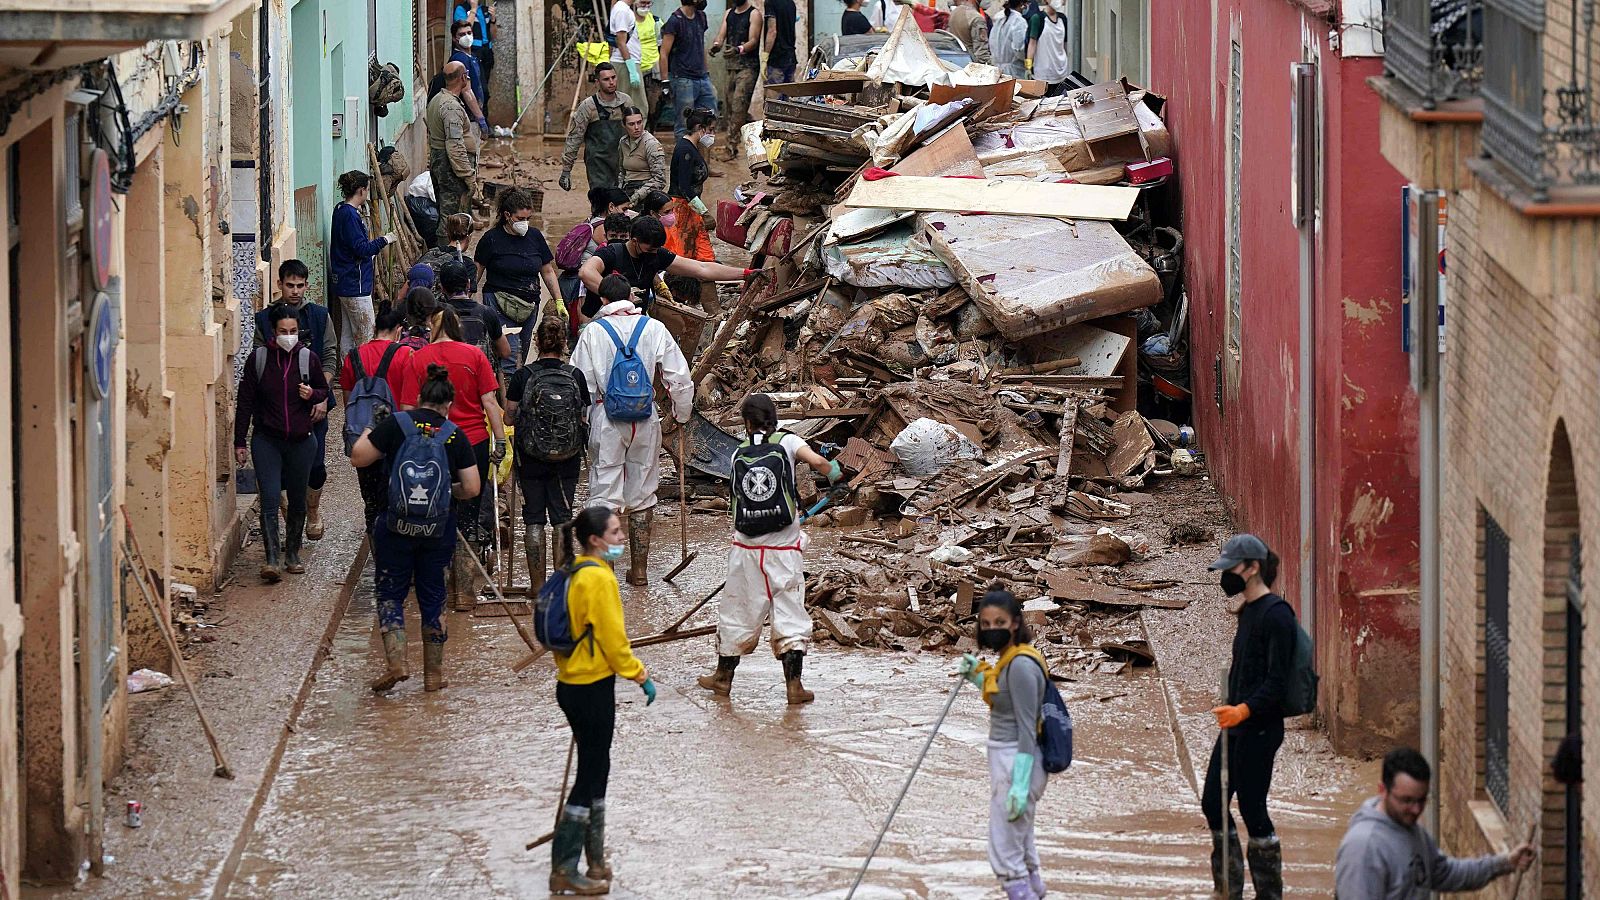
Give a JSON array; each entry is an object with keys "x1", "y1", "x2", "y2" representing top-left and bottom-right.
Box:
[{"x1": 1384, "y1": 0, "x2": 1483, "y2": 109}]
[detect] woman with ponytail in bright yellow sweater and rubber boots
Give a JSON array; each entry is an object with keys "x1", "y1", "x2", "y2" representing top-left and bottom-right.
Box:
[{"x1": 550, "y1": 506, "x2": 656, "y2": 897}]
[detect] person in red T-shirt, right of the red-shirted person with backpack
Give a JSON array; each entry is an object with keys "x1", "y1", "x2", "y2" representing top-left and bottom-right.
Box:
[{"x1": 395, "y1": 306, "x2": 506, "y2": 610}]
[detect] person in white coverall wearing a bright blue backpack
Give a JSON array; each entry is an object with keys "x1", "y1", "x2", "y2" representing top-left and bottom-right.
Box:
[{"x1": 573, "y1": 275, "x2": 688, "y2": 582}]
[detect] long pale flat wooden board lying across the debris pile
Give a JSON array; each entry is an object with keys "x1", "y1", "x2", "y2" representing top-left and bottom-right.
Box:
[{"x1": 845, "y1": 175, "x2": 1139, "y2": 221}]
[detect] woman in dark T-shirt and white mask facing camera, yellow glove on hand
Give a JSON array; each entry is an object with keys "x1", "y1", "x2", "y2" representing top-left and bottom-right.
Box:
[{"x1": 474, "y1": 187, "x2": 566, "y2": 375}]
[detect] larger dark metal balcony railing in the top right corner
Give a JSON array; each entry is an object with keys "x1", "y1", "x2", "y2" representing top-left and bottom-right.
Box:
[{"x1": 1483, "y1": 0, "x2": 1600, "y2": 202}]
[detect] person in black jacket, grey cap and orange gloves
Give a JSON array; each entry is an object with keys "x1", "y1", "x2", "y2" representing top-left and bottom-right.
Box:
[{"x1": 1200, "y1": 535, "x2": 1299, "y2": 900}]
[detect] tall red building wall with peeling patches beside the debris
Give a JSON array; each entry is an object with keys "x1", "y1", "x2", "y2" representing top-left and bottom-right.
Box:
[{"x1": 1150, "y1": 0, "x2": 1418, "y2": 753}]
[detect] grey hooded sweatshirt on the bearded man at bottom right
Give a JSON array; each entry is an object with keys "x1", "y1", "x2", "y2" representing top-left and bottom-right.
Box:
[{"x1": 1333, "y1": 798, "x2": 1509, "y2": 900}]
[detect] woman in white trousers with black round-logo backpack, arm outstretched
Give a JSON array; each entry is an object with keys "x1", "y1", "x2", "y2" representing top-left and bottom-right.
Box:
[{"x1": 699, "y1": 394, "x2": 843, "y2": 705}]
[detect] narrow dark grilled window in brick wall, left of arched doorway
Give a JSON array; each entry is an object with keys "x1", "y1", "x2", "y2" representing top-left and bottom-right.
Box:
[{"x1": 1482, "y1": 514, "x2": 1510, "y2": 814}]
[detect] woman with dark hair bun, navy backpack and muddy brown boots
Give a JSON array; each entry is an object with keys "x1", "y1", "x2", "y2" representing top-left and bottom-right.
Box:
[{"x1": 350, "y1": 364, "x2": 482, "y2": 692}]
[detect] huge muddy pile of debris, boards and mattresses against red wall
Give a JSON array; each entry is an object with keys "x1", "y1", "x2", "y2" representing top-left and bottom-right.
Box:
[{"x1": 669, "y1": 16, "x2": 1198, "y2": 677}]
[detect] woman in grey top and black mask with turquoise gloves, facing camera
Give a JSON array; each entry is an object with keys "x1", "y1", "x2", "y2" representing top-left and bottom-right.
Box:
[{"x1": 958, "y1": 589, "x2": 1050, "y2": 900}]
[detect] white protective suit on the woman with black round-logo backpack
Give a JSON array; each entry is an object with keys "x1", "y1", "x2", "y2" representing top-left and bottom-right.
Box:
[{"x1": 717, "y1": 434, "x2": 811, "y2": 657}]
